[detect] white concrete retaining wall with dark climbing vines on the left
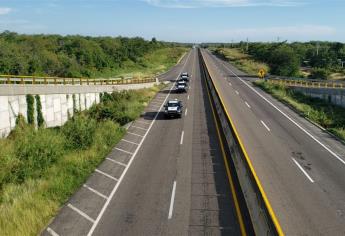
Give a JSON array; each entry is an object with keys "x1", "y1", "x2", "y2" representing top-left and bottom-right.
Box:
[{"x1": 0, "y1": 83, "x2": 155, "y2": 138}]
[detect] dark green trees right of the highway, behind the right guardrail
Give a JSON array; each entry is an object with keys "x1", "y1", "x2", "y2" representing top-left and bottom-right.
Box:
[{"x1": 206, "y1": 42, "x2": 345, "y2": 79}]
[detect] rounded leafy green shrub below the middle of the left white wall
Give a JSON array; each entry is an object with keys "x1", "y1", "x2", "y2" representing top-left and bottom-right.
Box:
[{"x1": 61, "y1": 114, "x2": 96, "y2": 150}]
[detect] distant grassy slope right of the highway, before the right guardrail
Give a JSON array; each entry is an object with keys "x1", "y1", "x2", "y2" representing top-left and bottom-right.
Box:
[{"x1": 213, "y1": 48, "x2": 269, "y2": 75}]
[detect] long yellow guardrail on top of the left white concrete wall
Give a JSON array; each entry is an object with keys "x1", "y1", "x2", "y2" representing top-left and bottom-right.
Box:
[{"x1": 0, "y1": 75, "x2": 156, "y2": 85}]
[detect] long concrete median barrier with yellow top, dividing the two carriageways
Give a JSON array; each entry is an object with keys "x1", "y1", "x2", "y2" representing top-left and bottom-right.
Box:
[{"x1": 199, "y1": 50, "x2": 284, "y2": 235}]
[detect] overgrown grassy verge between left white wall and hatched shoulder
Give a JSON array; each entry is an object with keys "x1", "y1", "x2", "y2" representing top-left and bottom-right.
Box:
[{"x1": 0, "y1": 86, "x2": 161, "y2": 235}]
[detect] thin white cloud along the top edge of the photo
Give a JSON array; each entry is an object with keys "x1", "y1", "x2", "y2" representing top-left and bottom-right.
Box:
[{"x1": 143, "y1": 0, "x2": 306, "y2": 8}]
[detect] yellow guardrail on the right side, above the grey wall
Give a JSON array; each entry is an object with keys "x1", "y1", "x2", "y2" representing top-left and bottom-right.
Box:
[{"x1": 267, "y1": 77, "x2": 345, "y2": 89}]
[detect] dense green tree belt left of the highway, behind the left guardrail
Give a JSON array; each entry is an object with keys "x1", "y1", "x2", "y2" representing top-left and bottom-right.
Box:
[{"x1": 0, "y1": 31, "x2": 185, "y2": 77}]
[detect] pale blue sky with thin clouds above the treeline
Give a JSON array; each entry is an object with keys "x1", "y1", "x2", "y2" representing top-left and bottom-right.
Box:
[{"x1": 0, "y1": 0, "x2": 345, "y2": 43}]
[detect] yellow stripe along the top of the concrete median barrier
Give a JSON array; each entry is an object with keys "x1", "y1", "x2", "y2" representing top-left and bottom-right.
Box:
[{"x1": 205, "y1": 55, "x2": 284, "y2": 236}]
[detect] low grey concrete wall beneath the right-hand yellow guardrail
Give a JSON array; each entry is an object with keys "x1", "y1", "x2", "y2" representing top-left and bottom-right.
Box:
[{"x1": 290, "y1": 86, "x2": 345, "y2": 108}]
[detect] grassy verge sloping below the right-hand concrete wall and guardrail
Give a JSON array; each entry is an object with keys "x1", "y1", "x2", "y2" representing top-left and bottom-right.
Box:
[{"x1": 254, "y1": 80, "x2": 345, "y2": 140}]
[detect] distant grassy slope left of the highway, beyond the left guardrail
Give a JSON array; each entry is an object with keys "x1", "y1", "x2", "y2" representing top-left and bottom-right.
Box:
[{"x1": 92, "y1": 47, "x2": 189, "y2": 78}]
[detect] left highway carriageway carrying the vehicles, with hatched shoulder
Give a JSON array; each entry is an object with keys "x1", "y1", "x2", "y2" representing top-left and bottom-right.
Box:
[{"x1": 42, "y1": 49, "x2": 253, "y2": 236}]
